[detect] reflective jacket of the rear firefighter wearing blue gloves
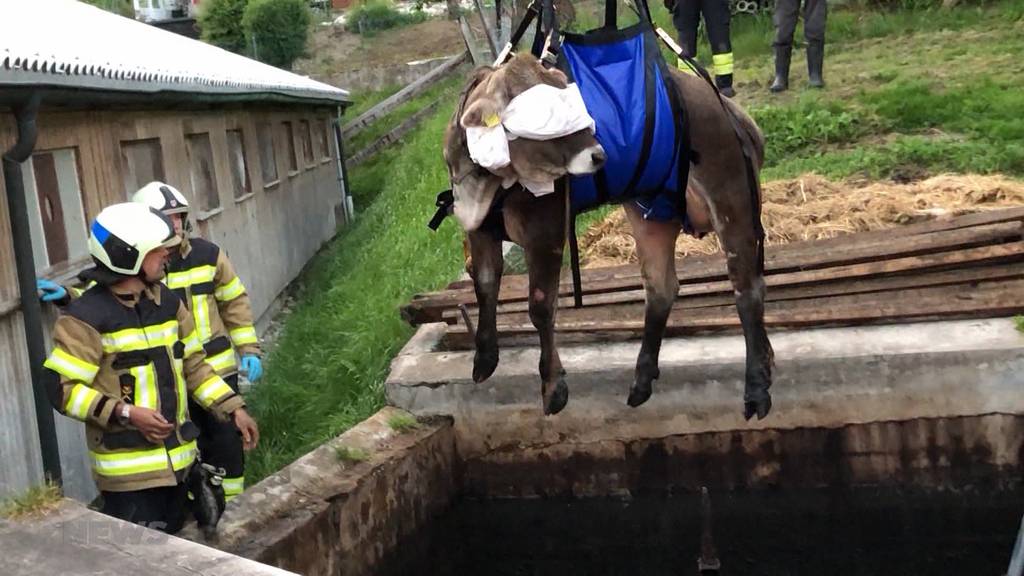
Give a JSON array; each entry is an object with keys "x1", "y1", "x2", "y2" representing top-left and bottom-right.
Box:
[{"x1": 164, "y1": 238, "x2": 260, "y2": 377}]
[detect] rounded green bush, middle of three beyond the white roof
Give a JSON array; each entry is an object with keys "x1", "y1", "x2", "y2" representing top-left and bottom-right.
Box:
[{"x1": 242, "y1": 0, "x2": 312, "y2": 70}]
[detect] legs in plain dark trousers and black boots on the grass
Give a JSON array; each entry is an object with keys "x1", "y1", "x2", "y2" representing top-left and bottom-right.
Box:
[{"x1": 769, "y1": 0, "x2": 828, "y2": 92}]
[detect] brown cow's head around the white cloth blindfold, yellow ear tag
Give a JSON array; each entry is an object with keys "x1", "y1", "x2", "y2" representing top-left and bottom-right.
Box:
[{"x1": 444, "y1": 55, "x2": 605, "y2": 231}]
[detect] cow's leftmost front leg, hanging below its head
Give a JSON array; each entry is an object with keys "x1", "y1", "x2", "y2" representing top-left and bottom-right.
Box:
[{"x1": 468, "y1": 230, "x2": 505, "y2": 382}]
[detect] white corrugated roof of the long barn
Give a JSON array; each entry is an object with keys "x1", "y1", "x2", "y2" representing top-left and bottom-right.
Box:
[{"x1": 0, "y1": 0, "x2": 350, "y2": 104}]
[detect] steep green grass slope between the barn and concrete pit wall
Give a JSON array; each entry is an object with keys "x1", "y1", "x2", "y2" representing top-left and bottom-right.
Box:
[{"x1": 247, "y1": 105, "x2": 463, "y2": 482}]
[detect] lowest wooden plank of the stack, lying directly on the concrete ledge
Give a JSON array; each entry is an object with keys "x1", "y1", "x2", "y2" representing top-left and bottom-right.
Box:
[{"x1": 445, "y1": 280, "x2": 1024, "y2": 348}]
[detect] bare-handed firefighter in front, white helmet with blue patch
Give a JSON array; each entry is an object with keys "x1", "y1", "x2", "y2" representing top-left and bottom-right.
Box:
[{"x1": 43, "y1": 202, "x2": 259, "y2": 534}]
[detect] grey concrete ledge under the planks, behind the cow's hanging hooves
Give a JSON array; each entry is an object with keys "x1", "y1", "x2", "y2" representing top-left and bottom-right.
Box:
[{"x1": 387, "y1": 319, "x2": 1024, "y2": 459}]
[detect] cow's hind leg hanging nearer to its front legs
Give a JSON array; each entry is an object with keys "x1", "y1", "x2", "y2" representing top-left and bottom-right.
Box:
[{"x1": 625, "y1": 204, "x2": 679, "y2": 408}]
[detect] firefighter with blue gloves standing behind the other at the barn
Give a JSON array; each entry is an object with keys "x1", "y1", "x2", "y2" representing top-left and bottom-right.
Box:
[{"x1": 132, "y1": 182, "x2": 263, "y2": 500}]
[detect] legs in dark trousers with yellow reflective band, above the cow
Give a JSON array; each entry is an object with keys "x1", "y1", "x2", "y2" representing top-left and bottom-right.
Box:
[{"x1": 665, "y1": 0, "x2": 736, "y2": 98}]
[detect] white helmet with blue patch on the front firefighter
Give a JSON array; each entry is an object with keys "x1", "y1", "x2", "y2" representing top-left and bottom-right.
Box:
[{"x1": 89, "y1": 202, "x2": 181, "y2": 276}]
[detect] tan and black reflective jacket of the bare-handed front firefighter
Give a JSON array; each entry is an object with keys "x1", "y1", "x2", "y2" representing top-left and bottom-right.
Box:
[{"x1": 43, "y1": 284, "x2": 245, "y2": 492}]
